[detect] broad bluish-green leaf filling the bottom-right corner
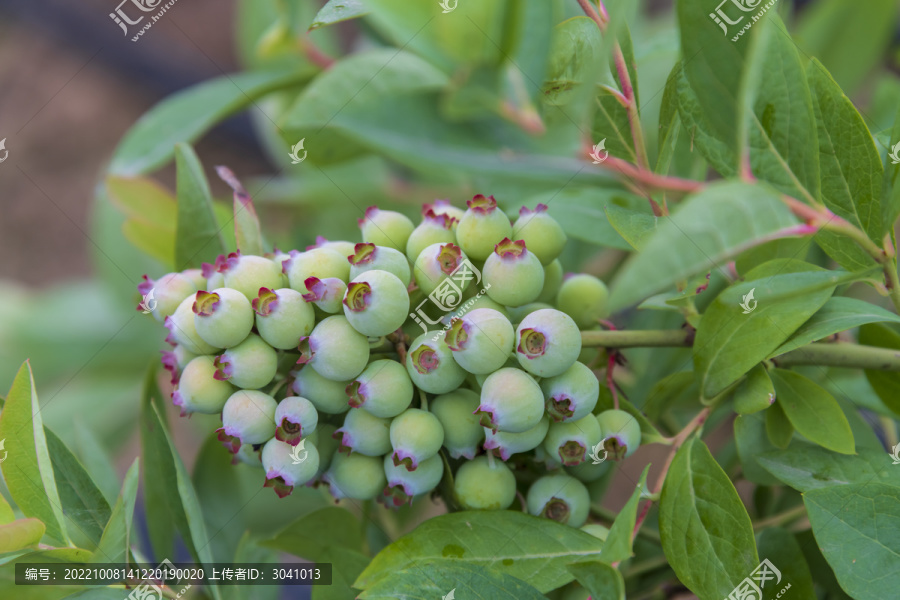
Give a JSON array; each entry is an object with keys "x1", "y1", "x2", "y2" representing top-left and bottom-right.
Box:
[{"x1": 803, "y1": 482, "x2": 900, "y2": 600}]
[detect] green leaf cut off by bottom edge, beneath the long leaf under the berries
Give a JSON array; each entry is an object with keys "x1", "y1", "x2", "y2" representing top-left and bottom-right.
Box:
[{"x1": 358, "y1": 560, "x2": 546, "y2": 600}]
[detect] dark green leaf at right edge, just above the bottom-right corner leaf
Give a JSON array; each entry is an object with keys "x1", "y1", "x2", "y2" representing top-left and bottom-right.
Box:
[{"x1": 759, "y1": 444, "x2": 900, "y2": 492}]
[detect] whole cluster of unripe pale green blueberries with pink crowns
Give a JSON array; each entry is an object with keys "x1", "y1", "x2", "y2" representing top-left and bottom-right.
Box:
[{"x1": 139, "y1": 195, "x2": 641, "y2": 527}]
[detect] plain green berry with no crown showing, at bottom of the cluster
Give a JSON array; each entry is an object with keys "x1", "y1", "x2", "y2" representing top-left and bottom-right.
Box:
[{"x1": 453, "y1": 456, "x2": 516, "y2": 510}]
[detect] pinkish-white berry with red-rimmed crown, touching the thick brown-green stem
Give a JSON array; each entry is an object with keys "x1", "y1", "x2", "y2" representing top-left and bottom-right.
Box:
[{"x1": 516, "y1": 308, "x2": 581, "y2": 377}]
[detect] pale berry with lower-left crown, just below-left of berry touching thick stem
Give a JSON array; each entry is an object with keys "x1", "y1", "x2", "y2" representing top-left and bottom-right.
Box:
[{"x1": 476, "y1": 368, "x2": 544, "y2": 433}]
